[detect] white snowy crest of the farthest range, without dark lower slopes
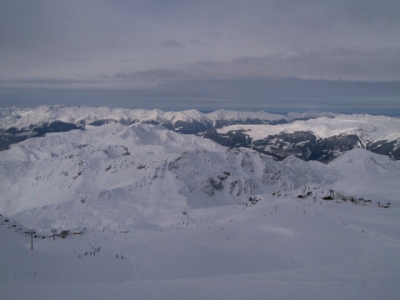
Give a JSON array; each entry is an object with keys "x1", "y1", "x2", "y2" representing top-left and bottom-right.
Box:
[{"x1": 0, "y1": 105, "x2": 335, "y2": 130}]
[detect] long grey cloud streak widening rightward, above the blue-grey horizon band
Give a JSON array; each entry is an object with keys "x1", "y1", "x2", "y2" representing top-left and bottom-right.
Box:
[{"x1": 0, "y1": 48, "x2": 400, "y2": 89}]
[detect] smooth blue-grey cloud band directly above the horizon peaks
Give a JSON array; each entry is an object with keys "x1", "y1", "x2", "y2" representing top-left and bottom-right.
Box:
[{"x1": 0, "y1": 77, "x2": 400, "y2": 116}]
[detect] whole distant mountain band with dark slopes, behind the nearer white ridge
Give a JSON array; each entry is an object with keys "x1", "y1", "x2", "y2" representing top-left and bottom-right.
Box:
[{"x1": 0, "y1": 106, "x2": 400, "y2": 163}]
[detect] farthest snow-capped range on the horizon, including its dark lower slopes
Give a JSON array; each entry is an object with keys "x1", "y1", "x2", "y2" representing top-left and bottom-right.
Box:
[{"x1": 0, "y1": 106, "x2": 334, "y2": 150}]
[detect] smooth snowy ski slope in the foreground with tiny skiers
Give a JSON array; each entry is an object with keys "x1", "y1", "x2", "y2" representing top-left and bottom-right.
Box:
[{"x1": 0, "y1": 196, "x2": 400, "y2": 299}]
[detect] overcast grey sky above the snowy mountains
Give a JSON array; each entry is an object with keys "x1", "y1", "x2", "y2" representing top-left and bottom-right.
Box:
[{"x1": 0, "y1": 0, "x2": 400, "y2": 115}]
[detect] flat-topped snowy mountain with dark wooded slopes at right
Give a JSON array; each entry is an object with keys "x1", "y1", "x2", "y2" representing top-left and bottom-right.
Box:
[{"x1": 208, "y1": 115, "x2": 400, "y2": 162}]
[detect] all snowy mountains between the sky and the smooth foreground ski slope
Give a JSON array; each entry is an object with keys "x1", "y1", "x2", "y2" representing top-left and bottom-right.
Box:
[{"x1": 0, "y1": 106, "x2": 400, "y2": 229}]
